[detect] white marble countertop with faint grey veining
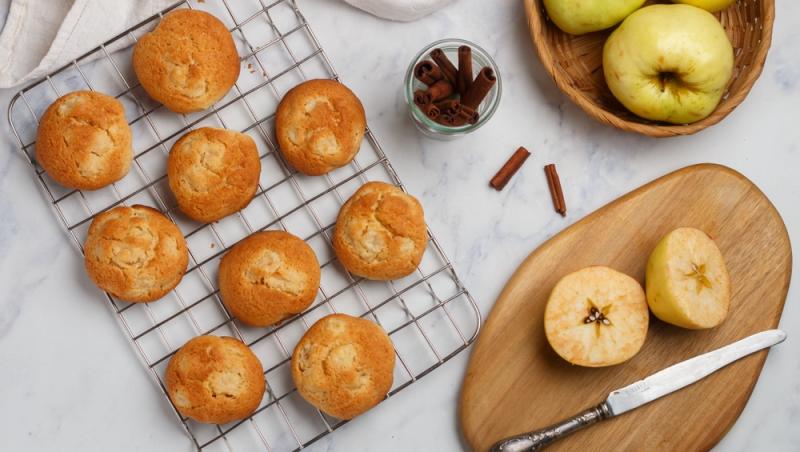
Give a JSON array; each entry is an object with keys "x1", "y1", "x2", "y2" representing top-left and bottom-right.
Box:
[{"x1": 0, "y1": 0, "x2": 800, "y2": 451}]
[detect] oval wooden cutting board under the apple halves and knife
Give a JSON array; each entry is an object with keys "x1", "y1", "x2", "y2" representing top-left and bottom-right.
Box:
[{"x1": 460, "y1": 164, "x2": 792, "y2": 451}]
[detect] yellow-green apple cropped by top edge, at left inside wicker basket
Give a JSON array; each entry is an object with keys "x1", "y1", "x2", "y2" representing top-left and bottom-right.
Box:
[{"x1": 544, "y1": 0, "x2": 645, "y2": 35}]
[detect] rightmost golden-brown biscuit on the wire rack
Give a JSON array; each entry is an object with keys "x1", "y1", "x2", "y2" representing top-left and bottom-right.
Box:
[{"x1": 333, "y1": 182, "x2": 427, "y2": 281}]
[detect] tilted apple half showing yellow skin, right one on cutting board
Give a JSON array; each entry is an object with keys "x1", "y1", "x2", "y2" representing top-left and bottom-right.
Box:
[{"x1": 646, "y1": 228, "x2": 731, "y2": 329}]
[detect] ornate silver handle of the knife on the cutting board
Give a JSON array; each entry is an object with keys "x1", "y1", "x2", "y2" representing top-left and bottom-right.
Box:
[{"x1": 489, "y1": 402, "x2": 611, "y2": 452}]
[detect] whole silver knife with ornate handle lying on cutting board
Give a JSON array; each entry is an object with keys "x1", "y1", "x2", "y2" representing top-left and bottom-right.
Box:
[{"x1": 489, "y1": 330, "x2": 786, "y2": 452}]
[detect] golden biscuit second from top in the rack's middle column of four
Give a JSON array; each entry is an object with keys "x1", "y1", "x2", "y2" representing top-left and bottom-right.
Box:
[{"x1": 167, "y1": 127, "x2": 261, "y2": 223}]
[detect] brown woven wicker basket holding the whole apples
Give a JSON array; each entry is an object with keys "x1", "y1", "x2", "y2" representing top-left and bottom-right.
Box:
[{"x1": 524, "y1": 0, "x2": 775, "y2": 137}]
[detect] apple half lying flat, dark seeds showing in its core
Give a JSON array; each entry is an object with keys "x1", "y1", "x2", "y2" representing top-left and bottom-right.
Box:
[{"x1": 544, "y1": 267, "x2": 650, "y2": 367}]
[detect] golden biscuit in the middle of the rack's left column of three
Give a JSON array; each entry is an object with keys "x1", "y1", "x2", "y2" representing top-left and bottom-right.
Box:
[{"x1": 83, "y1": 205, "x2": 189, "y2": 303}]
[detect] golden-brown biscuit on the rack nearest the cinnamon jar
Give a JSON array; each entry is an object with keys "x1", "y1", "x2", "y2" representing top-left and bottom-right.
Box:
[{"x1": 275, "y1": 80, "x2": 367, "y2": 176}]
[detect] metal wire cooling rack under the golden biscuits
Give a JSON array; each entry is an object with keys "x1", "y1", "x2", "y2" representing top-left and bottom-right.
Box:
[{"x1": 8, "y1": 0, "x2": 481, "y2": 452}]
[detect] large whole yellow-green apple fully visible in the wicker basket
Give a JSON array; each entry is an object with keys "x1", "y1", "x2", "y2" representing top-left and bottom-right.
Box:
[{"x1": 603, "y1": 4, "x2": 733, "y2": 124}]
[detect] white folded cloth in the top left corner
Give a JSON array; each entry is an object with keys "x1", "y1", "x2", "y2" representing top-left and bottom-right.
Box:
[{"x1": 0, "y1": 0, "x2": 176, "y2": 88}]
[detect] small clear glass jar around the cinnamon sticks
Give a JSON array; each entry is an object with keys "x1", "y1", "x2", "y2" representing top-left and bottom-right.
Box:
[{"x1": 404, "y1": 39, "x2": 503, "y2": 140}]
